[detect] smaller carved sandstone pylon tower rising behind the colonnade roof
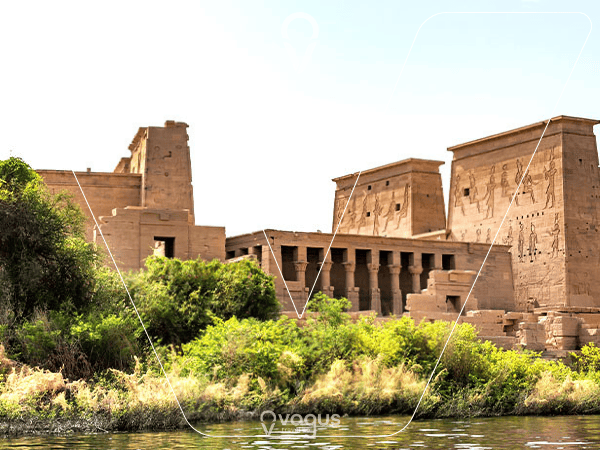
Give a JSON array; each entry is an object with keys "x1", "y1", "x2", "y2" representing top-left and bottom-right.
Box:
[{"x1": 332, "y1": 159, "x2": 446, "y2": 237}]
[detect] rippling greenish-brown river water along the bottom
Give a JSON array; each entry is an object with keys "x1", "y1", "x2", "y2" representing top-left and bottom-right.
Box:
[{"x1": 0, "y1": 416, "x2": 600, "y2": 450}]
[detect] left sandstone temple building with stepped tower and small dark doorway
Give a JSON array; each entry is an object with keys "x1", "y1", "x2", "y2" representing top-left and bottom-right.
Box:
[{"x1": 38, "y1": 121, "x2": 225, "y2": 270}]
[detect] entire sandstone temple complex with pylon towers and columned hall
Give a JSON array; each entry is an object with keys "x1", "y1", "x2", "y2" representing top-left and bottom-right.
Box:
[{"x1": 39, "y1": 116, "x2": 600, "y2": 355}]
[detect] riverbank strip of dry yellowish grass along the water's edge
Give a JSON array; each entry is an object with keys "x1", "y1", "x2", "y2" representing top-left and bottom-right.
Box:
[{"x1": 0, "y1": 322, "x2": 600, "y2": 436}]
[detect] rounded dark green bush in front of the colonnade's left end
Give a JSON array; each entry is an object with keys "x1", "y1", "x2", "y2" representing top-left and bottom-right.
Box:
[{"x1": 130, "y1": 257, "x2": 280, "y2": 345}]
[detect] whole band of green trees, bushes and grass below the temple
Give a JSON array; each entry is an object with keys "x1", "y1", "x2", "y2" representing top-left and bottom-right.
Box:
[{"x1": 0, "y1": 158, "x2": 600, "y2": 430}]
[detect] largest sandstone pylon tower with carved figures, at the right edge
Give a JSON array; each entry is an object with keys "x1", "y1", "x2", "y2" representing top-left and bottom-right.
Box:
[{"x1": 448, "y1": 116, "x2": 600, "y2": 311}]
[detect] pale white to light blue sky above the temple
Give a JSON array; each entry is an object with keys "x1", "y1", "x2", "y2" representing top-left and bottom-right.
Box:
[{"x1": 0, "y1": 0, "x2": 600, "y2": 236}]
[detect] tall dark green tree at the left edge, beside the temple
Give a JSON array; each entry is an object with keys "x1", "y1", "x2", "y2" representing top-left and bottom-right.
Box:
[{"x1": 0, "y1": 157, "x2": 99, "y2": 321}]
